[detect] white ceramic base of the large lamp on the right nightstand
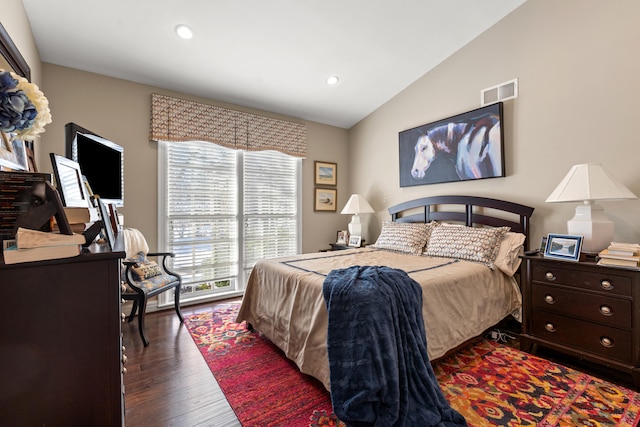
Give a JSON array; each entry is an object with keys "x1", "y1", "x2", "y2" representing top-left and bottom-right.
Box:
[{"x1": 567, "y1": 202, "x2": 614, "y2": 254}]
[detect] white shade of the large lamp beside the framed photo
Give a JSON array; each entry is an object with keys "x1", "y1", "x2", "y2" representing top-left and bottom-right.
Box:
[{"x1": 546, "y1": 163, "x2": 637, "y2": 203}]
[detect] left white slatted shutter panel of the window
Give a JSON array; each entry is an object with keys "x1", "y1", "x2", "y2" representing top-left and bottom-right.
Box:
[{"x1": 165, "y1": 142, "x2": 238, "y2": 290}]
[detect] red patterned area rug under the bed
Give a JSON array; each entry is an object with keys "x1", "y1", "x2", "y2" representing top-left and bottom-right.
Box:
[{"x1": 185, "y1": 302, "x2": 640, "y2": 427}]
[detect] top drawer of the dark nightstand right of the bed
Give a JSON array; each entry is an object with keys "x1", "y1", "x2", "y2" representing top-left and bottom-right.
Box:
[{"x1": 532, "y1": 263, "x2": 632, "y2": 297}]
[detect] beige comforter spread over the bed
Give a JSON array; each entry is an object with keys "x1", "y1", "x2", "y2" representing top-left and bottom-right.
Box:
[{"x1": 237, "y1": 248, "x2": 521, "y2": 390}]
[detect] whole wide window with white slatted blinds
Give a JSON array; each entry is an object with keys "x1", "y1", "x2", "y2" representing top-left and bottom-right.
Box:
[{"x1": 158, "y1": 141, "x2": 301, "y2": 305}]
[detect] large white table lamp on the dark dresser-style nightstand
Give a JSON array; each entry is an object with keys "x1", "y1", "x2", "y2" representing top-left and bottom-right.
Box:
[{"x1": 546, "y1": 163, "x2": 637, "y2": 253}]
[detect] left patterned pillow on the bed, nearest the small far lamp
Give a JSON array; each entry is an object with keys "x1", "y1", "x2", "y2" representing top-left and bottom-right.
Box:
[{"x1": 372, "y1": 221, "x2": 434, "y2": 255}]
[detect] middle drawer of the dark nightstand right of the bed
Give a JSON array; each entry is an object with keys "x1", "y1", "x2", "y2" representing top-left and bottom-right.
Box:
[{"x1": 531, "y1": 283, "x2": 632, "y2": 330}]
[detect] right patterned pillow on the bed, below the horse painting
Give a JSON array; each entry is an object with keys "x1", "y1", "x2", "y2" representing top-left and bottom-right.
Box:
[{"x1": 424, "y1": 227, "x2": 510, "y2": 269}]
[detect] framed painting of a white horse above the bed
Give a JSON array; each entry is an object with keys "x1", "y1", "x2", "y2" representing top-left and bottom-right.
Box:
[{"x1": 399, "y1": 102, "x2": 505, "y2": 187}]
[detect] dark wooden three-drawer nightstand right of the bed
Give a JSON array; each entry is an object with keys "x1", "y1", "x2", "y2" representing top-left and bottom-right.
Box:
[{"x1": 520, "y1": 255, "x2": 640, "y2": 387}]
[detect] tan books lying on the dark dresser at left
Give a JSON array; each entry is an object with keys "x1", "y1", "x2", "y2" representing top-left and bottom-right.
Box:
[{"x1": 2, "y1": 227, "x2": 85, "y2": 264}]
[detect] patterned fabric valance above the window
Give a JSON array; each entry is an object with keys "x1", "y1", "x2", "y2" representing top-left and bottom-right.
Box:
[{"x1": 150, "y1": 93, "x2": 307, "y2": 158}]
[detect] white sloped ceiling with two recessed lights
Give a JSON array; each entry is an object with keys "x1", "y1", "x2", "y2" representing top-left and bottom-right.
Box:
[{"x1": 23, "y1": 0, "x2": 525, "y2": 128}]
